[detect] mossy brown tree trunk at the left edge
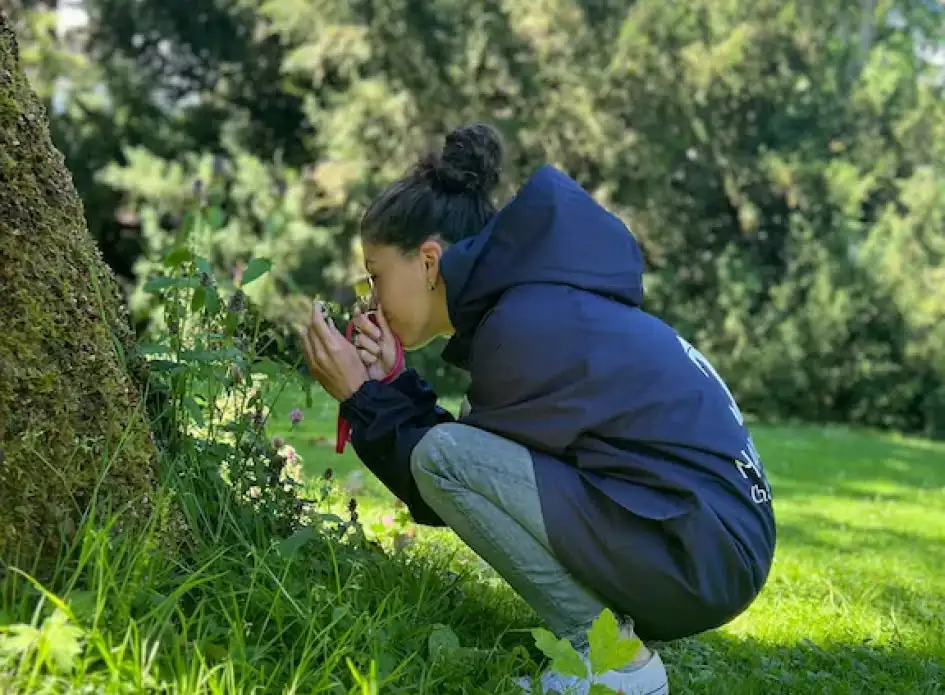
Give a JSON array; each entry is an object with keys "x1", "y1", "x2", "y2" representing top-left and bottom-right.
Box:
[{"x1": 0, "y1": 12, "x2": 156, "y2": 567}]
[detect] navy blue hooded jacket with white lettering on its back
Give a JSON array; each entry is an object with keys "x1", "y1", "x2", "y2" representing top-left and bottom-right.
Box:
[{"x1": 342, "y1": 166, "x2": 775, "y2": 640}]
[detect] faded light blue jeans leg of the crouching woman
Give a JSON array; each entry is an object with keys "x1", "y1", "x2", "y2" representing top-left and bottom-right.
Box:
[{"x1": 410, "y1": 423, "x2": 604, "y2": 649}]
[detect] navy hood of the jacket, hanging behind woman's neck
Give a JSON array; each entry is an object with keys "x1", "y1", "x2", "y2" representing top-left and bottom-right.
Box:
[{"x1": 440, "y1": 165, "x2": 644, "y2": 366}]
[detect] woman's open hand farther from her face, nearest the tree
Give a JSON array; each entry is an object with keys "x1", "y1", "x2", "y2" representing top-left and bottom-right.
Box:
[{"x1": 302, "y1": 302, "x2": 369, "y2": 401}]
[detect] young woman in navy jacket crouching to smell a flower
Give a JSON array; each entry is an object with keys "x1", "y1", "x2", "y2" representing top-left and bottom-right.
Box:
[{"x1": 304, "y1": 124, "x2": 775, "y2": 695}]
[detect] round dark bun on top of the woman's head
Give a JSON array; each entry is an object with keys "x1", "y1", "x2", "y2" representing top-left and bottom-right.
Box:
[{"x1": 433, "y1": 123, "x2": 503, "y2": 197}]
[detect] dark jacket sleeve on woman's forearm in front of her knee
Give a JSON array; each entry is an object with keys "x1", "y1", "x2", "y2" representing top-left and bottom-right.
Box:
[{"x1": 341, "y1": 369, "x2": 453, "y2": 526}]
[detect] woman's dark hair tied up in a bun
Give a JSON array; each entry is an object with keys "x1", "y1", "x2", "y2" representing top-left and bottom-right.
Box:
[{"x1": 361, "y1": 123, "x2": 503, "y2": 252}]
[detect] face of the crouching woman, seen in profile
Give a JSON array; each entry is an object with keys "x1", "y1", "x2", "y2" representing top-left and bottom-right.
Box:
[{"x1": 363, "y1": 240, "x2": 451, "y2": 350}]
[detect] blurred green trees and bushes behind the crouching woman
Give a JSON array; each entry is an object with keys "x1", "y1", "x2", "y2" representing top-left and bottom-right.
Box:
[{"x1": 0, "y1": 0, "x2": 945, "y2": 436}]
